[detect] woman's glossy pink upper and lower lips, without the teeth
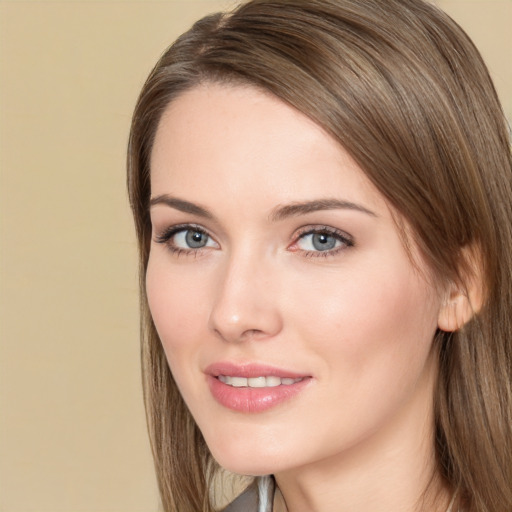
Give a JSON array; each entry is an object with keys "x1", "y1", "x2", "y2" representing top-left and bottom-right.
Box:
[{"x1": 205, "y1": 362, "x2": 311, "y2": 413}]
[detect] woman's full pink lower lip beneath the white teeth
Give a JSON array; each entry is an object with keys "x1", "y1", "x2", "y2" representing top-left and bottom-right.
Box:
[{"x1": 208, "y1": 375, "x2": 311, "y2": 413}]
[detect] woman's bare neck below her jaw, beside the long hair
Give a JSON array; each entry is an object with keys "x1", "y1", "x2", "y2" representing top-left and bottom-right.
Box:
[{"x1": 275, "y1": 356, "x2": 451, "y2": 512}]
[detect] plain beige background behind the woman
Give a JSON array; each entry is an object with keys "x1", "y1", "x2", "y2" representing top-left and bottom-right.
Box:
[{"x1": 0, "y1": 0, "x2": 512, "y2": 512}]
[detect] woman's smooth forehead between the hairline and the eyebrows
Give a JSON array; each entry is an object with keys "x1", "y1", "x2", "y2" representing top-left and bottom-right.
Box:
[{"x1": 151, "y1": 84, "x2": 384, "y2": 211}]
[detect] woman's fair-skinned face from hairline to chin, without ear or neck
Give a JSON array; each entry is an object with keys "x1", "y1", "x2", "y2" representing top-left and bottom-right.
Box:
[{"x1": 146, "y1": 85, "x2": 440, "y2": 474}]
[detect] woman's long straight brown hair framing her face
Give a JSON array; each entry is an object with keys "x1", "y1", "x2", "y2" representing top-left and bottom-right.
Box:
[{"x1": 128, "y1": 0, "x2": 512, "y2": 512}]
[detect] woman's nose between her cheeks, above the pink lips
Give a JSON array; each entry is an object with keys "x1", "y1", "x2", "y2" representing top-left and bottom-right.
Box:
[{"x1": 209, "y1": 250, "x2": 283, "y2": 342}]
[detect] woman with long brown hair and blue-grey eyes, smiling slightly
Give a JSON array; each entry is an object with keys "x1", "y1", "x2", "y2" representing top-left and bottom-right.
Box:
[{"x1": 128, "y1": 0, "x2": 512, "y2": 512}]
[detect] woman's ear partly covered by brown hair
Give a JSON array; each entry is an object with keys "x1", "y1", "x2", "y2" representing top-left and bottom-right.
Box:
[{"x1": 437, "y1": 245, "x2": 485, "y2": 332}]
